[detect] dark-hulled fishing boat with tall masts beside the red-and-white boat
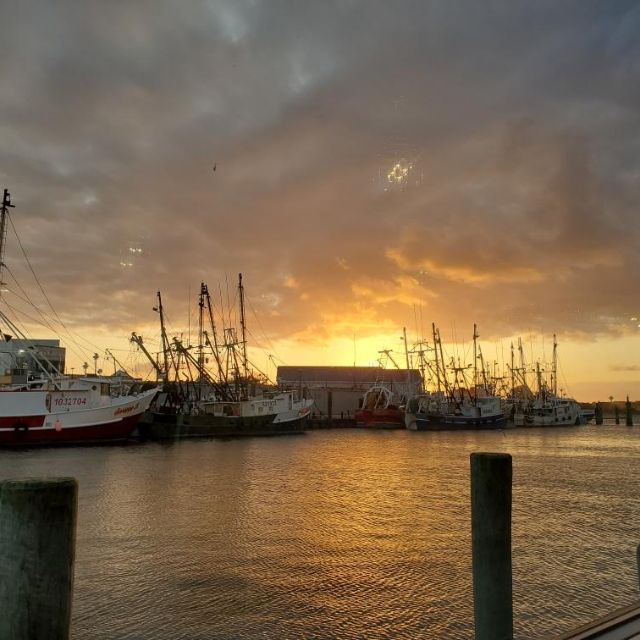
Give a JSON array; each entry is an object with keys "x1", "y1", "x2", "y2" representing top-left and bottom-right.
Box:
[{"x1": 131, "y1": 274, "x2": 313, "y2": 440}]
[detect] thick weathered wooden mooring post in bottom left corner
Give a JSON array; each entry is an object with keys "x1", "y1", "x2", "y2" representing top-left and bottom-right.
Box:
[{"x1": 0, "y1": 478, "x2": 78, "y2": 640}]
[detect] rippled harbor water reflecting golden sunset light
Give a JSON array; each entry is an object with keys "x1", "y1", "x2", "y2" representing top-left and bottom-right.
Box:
[{"x1": 0, "y1": 425, "x2": 640, "y2": 640}]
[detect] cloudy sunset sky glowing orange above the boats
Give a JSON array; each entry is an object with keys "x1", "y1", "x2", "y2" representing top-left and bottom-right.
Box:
[{"x1": 0, "y1": 0, "x2": 640, "y2": 400}]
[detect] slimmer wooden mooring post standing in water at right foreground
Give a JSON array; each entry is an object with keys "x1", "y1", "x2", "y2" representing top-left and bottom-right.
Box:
[{"x1": 471, "y1": 453, "x2": 513, "y2": 640}]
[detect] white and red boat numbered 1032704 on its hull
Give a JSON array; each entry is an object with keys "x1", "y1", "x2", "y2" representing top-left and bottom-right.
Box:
[{"x1": 0, "y1": 189, "x2": 157, "y2": 447}]
